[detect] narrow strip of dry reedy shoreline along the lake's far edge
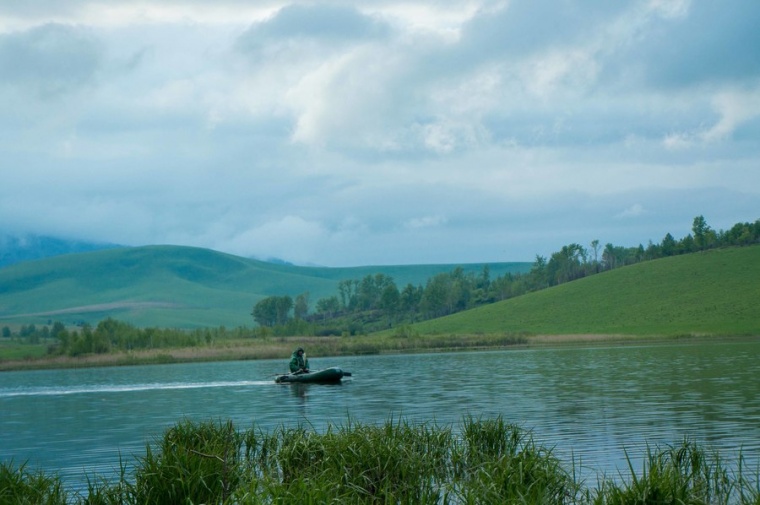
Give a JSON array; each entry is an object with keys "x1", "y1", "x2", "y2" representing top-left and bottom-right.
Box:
[{"x1": 0, "y1": 333, "x2": 758, "y2": 373}]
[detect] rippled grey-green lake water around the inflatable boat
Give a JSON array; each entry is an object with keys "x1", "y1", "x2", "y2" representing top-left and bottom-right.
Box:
[{"x1": 0, "y1": 339, "x2": 760, "y2": 488}]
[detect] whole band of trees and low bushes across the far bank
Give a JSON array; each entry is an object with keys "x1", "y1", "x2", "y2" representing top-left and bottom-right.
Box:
[{"x1": 0, "y1": 216, "x2": 760, "y2": 346}]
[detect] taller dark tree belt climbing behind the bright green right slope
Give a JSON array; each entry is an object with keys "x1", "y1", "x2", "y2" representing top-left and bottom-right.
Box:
[{"x1": 251, "y1": 215, "x2": 760, "y2": 335}]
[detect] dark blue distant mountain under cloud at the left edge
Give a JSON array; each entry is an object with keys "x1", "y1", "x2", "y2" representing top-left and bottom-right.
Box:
[{"x1": 0, "y1": 235, "x2": 120, "y2": 267}]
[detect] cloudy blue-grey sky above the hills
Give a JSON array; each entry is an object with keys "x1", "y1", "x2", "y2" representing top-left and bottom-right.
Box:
[{"x1": 0, "y1": 0, "x2": 760, "y2": 267}]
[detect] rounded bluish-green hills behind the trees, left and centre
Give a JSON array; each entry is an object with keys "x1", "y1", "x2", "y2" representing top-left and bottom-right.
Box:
[{"x1": 0, "y1": 246, "x2": 531, "y2": 328}]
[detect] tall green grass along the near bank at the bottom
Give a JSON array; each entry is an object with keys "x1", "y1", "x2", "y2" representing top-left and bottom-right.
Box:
[{"x1": 0, "y1": 418, "x2": 760, "y2": 505}]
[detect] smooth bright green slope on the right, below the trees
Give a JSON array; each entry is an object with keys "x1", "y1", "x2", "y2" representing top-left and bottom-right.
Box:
[{"x1": 414, "y1": 246, "x2": 760, "y2": 335}]
